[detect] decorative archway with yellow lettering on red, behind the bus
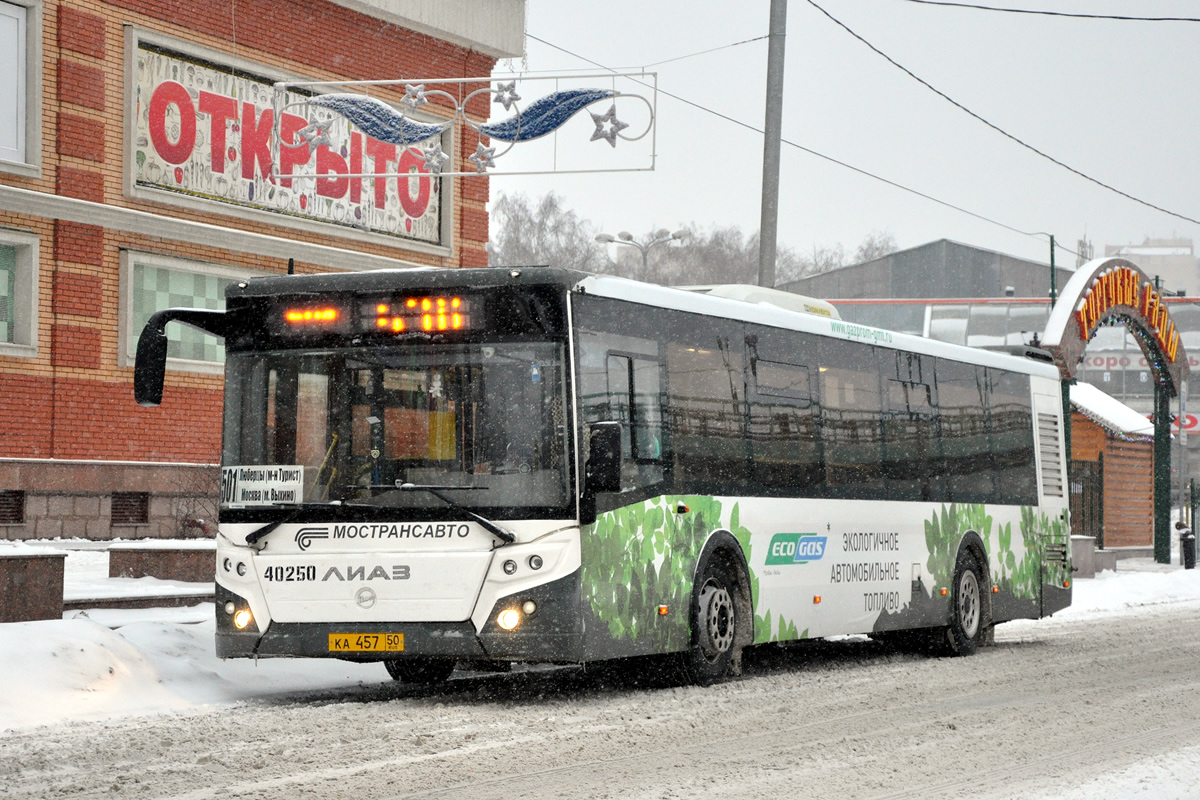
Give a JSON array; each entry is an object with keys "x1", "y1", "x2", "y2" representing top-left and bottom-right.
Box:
[{"x1": 1042, "y1": 258, "x2": 1189, "y2": 564}]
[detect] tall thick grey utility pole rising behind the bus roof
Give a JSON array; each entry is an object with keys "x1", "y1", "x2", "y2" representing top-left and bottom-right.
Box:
[{"x1": 758, "y1": 0, "x2": 787, "y2": 288}]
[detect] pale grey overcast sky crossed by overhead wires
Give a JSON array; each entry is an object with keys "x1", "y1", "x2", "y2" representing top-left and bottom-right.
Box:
[{"x1": 492, "y1": 0, "x2": 1200, "y2": 275}]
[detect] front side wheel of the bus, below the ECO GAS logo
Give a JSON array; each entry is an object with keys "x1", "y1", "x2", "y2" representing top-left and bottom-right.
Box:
[{"x1": 684, "y1": 553, "x2": 748, "y2": 686}]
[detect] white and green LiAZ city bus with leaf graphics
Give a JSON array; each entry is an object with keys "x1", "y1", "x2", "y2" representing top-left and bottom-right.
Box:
[{"x1": 134, "y1": 267, "x2": 1070, "y2": 685}]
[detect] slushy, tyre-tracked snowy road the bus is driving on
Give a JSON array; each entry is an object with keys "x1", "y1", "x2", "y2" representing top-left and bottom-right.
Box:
[{"x1": 0, "y1": 601, "x2": 1200, "y2": 800}]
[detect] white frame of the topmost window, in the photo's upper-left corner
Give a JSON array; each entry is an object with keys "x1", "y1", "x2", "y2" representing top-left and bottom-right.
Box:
[{"x1": 0, "y1": 0, "x2": 42, "y2": 178}]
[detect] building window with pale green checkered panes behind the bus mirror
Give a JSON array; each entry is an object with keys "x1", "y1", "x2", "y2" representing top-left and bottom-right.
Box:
[{"x1": 121, "y1": 251, "x2": 251, "y2": 372}]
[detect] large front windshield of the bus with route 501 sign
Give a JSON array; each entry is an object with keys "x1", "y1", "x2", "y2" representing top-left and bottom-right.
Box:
[{"x1": 221, "y1": 342, "x2": 570, "y2": 517}]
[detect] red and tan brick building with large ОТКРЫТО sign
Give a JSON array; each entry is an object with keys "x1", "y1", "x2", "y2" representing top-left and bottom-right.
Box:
[{"x1": 0, "y1": 0, "x2": 524, "y2": 539}]
